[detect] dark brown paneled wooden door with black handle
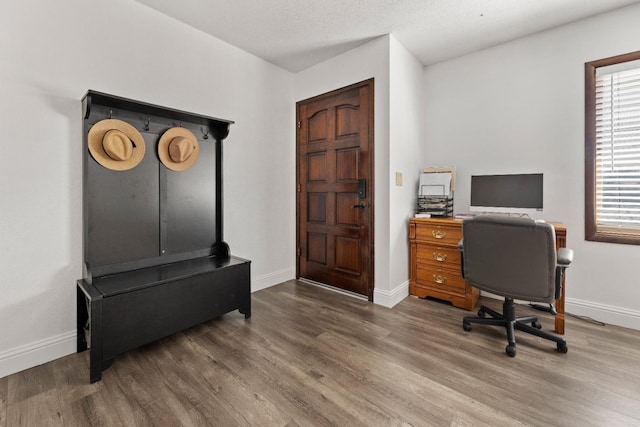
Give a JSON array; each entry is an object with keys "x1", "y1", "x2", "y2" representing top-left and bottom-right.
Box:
[{"x1": 296, "y1": 80, "x2": 374, "y2": 301}]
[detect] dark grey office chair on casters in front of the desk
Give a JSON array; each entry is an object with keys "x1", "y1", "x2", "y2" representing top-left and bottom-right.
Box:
[{"x1": 458, "y1": 215, "x2": 573, "y2": 357}]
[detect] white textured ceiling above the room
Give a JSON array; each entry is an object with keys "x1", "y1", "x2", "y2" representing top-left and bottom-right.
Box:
[{"x1": 135, "y1": 0, "x2": 640, "y2": 72}]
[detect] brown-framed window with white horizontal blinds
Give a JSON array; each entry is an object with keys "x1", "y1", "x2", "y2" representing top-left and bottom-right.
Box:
[{"x1": 585, "y1": 52, "x2": 640, "y2": 245}]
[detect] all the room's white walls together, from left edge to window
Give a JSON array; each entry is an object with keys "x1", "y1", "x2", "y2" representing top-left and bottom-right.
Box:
[{"x1": 6, "y1": 0, "x2": 640, "y2": 377}]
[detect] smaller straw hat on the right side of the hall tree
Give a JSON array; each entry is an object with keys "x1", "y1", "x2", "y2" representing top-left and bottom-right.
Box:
[{"x1": 158, "y1": 127, "x2": 200, "y2": 172}]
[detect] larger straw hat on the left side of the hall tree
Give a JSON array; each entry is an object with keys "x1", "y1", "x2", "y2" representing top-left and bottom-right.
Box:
[{"x1": 89, "y1": 119, "x2": 145, "y2": 171}]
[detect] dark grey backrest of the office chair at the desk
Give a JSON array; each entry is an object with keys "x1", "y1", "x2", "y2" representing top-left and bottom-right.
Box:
[{"x1": 462, "y1": 215, "x2": 557, "y2": 302}]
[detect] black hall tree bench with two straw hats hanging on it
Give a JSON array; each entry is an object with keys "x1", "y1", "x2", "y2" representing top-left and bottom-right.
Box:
[{"x1": 77, "y1": 90, "x2": 251, "y2": 382}]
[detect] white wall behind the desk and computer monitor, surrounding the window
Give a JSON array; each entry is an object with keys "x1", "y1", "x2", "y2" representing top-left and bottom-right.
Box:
[{"x1": 424, "y1": 5, "x2": 640, "y2": 329}]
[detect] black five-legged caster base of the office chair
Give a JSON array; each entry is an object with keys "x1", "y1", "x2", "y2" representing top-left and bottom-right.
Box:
[{"x1": 462, "y1": 298, "x2": 568, "y2": 357}]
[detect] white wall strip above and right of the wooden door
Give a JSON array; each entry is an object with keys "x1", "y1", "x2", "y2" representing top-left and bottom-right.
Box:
[{"x1": 294, "y1": 36, "x2": 393, "y2": 305}]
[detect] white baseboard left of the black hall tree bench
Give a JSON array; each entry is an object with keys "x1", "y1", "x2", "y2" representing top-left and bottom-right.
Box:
[{"x1": 0, "y1": 330, "x2": 76, "y2": 378}]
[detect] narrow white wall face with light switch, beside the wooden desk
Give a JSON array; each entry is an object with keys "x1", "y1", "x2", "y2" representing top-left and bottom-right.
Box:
[{"x1": 389, "y1": 35, "x2": 428, "y2": 305}]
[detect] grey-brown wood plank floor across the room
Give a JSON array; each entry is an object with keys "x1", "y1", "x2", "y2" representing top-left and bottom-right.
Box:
[{"x1": 0, "y1": 281, "x2": 640, "y2": 427}]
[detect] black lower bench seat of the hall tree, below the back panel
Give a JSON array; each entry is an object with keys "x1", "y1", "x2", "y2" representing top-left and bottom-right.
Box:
[{"x1": 77, "y1": 256, "x2": 251, "y2": 382}]
